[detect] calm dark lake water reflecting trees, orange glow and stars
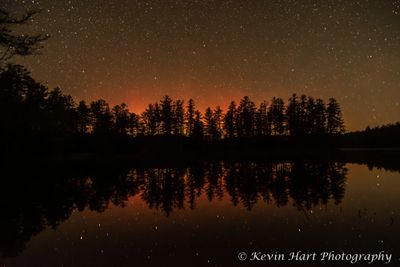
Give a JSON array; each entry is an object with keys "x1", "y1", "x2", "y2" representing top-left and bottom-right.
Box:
[{"x1": 0, "y1": 162, "x2": 400, "y2": 266}]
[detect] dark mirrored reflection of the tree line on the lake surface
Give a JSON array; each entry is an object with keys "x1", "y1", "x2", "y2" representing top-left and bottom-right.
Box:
[{"x1": 0, "y1": 162, "x2": 347, "y2": 258}]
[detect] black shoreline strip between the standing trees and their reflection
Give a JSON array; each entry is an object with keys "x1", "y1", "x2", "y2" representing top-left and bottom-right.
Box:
[{"x1": 1, "y1": 147, "x2": 400, "y2": 171}]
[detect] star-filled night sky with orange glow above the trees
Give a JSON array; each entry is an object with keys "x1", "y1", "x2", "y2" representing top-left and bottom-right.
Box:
[{"x1": 2, "y1": 0, "x2": 400, "y2": 130}]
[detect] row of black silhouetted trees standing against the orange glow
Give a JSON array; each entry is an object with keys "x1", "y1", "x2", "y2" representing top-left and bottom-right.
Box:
[{"x1": 0, "y1": 64, "x2": 344, "y2": 140}]
